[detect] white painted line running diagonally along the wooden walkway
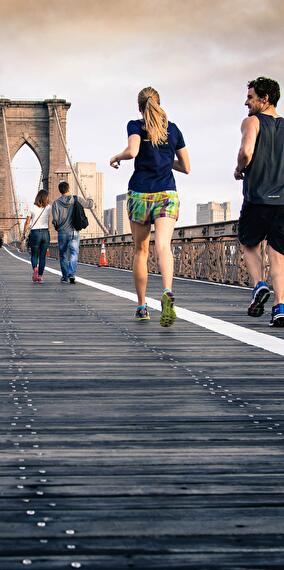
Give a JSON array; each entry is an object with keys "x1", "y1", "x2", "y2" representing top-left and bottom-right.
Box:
[{"x1": 3, "y1": 247, "x2": 284, "y2": 356}]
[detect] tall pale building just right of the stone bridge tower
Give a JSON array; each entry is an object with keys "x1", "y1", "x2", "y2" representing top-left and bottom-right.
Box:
[{"x1": 69, "y1": 162, "x2": 104, "y2": 239}]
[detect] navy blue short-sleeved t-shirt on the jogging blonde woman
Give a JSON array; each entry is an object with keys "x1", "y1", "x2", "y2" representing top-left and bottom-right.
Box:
[{"x1": 127, "y1": 119, "x2": 185, "y2": 194}]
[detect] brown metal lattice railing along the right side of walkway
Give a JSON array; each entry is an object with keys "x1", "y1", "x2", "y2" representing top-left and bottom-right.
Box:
[{"x1": 47, "y1": 220, "x2": 269, "y2": 285}]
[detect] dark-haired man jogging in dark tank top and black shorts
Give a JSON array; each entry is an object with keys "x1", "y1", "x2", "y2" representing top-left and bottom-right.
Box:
[{"x1": 234, "y1": 77, "x2": 284, "y2": 327}]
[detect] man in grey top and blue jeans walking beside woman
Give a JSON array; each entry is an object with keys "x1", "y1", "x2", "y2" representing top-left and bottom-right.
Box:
[{"x1": 52, "y1": 181, "x2": 93, "y2": 285}]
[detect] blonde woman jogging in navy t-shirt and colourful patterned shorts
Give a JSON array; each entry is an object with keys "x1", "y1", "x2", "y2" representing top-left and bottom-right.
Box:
[{"x1": 110, "y1": 87, "x2": 190, "y2": 327}]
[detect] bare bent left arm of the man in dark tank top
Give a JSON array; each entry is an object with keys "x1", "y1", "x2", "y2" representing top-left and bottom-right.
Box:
[{"x1": 234, "y1": 116, "x2": 259, "y2": 180}]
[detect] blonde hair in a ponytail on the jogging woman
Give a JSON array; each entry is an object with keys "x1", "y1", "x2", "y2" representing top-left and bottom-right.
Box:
[{"x1": 138, "y1": 87, "x2": 168, "y2": 145}]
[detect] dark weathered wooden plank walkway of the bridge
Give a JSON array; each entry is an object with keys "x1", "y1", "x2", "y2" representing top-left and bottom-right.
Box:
[{"x1": 0, "y1": 249, "x2": 284, "y2": 570}]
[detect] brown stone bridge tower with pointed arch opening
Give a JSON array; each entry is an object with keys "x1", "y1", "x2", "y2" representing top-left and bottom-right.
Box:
[{"x1": 0, "y1": 99, "x2": 70, "y2": 241}]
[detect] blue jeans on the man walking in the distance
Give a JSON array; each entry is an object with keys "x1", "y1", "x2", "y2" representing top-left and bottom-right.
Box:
[{"x1": 58, "y1": 230, "x2": 80, "y2": 280}]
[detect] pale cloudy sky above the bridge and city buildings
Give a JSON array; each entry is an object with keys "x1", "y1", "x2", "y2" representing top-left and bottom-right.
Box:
[{"x1": 0, "y1": 0, "x2": 284, "y2": 225}]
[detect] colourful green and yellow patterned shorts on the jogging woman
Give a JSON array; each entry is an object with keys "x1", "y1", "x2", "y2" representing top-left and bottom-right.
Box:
[{"x1": 127, "y1": 190, "x2": 179, "y2": 225}]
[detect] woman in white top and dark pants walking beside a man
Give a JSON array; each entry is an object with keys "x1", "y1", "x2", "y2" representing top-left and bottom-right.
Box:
[{"x1": 22, "y1": 190, "x2": 51, "y2": 284}]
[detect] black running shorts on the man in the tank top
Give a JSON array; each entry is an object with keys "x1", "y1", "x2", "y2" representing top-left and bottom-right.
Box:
[{"x1": 239, "y1": 202, "x2": 284, "y2": 255}]
